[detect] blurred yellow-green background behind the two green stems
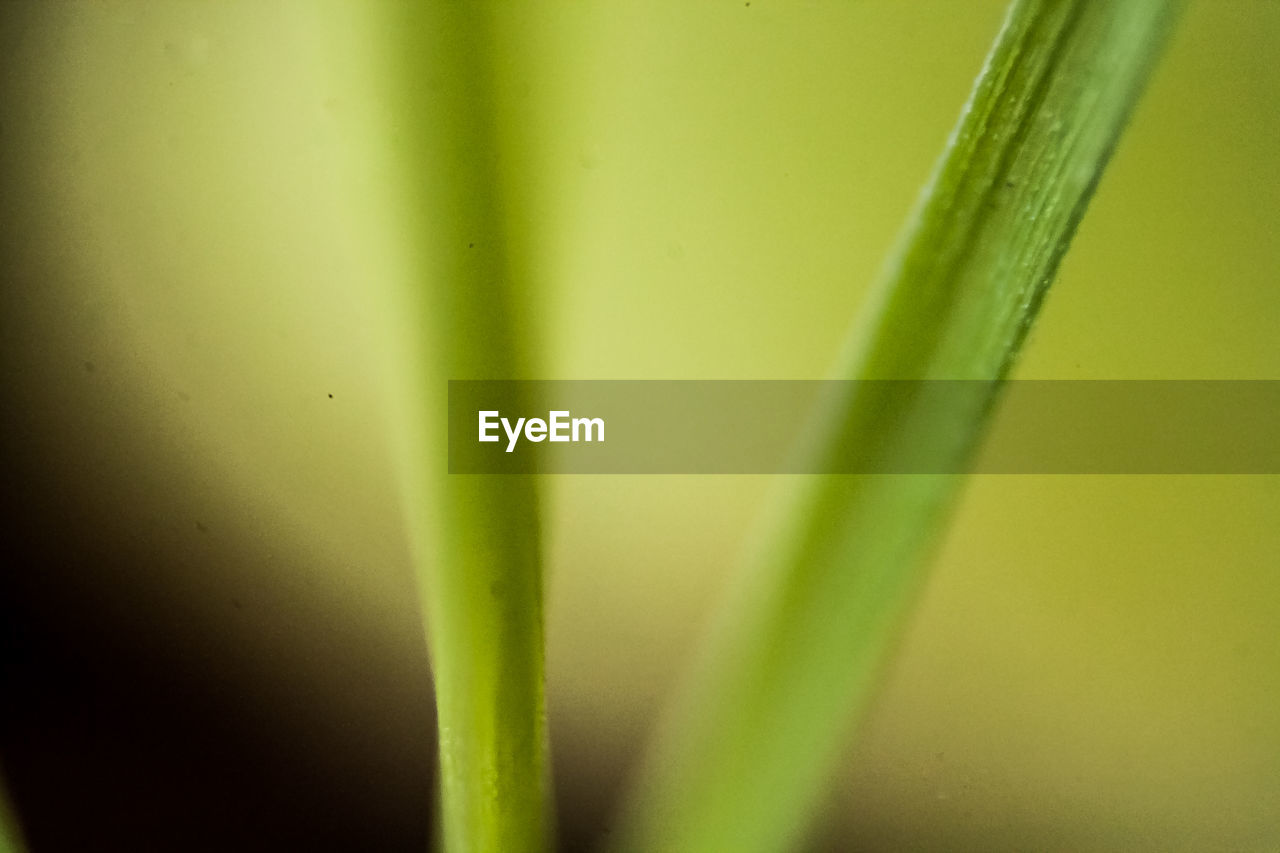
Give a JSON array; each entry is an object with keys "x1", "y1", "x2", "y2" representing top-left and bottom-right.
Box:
[{"x1": 0, "y1": 0, "x2": 1280, "y2": 850}]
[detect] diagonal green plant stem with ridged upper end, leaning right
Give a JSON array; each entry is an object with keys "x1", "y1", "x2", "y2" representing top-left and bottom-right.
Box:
[{"x1": 618, "y1": 0, "x2": 1178, "y2": 853}]
